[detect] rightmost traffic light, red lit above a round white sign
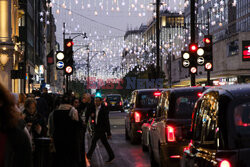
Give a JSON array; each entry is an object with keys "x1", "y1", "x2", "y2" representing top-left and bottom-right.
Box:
[{"x1": 203, "y1": 35, "x2": 213, "y2": 71}]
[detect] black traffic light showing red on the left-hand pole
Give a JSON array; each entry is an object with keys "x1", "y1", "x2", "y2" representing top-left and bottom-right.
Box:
[{"x1": 64, "y1": 39, "x2": 74, "y2": 75}]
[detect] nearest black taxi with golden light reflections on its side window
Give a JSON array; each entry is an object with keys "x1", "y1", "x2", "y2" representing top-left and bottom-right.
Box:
[{"x1": 181, "y1": 84, "x2": 250, "y2": 167}]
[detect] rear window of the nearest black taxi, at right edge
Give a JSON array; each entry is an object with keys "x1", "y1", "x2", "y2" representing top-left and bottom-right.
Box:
[{"x1": 233, "y1": 99, "x2": 250, "y2": 141}]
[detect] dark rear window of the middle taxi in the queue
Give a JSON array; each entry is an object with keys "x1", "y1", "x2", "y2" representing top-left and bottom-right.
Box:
[{"x1": 169, "y1": 93, "x2": 198, "y2": 119}]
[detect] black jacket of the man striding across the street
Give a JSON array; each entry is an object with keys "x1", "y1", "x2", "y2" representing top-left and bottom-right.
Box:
[{"x1": 91, "y1": 104, "x2": 111, "y2": 136}]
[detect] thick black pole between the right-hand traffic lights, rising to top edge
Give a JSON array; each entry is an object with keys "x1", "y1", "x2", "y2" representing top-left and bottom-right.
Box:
[{"x1": 190, "y1": 0, "x2": 195, "y2": 86}]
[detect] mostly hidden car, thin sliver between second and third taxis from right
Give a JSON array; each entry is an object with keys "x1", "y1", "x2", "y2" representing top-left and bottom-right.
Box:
[{"x1": 141, "y1": 118, "x2": 155, "y2": 151}]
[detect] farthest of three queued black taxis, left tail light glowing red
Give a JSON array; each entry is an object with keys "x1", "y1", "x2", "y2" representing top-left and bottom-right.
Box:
[{"x1": 125, "y1": 89, "x2": 161, "y2": 144}]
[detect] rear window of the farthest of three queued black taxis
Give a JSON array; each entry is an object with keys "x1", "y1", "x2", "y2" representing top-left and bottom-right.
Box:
[{"x1": 136, "y1": 92, "x2": 158, "y2": 108}]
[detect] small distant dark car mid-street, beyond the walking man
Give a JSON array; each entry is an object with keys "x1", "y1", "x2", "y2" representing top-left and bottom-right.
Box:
[{"x1": 105, "y1": 94, "x2": 124, "y2": 112}]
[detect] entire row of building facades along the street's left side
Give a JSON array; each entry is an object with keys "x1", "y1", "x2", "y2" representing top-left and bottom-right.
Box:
[{"x1": 0, "y1": 0, "x2": 56, "y2": 93}]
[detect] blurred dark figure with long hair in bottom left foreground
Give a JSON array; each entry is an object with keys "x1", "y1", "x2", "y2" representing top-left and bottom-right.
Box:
[{"x1": 0, "y1": 84, "x2": 32, "y2": 167}]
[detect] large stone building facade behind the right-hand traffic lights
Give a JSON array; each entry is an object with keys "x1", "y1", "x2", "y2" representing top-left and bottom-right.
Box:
[{"x1": 179, "y1": 0, "x2": 250, "y2": 86}]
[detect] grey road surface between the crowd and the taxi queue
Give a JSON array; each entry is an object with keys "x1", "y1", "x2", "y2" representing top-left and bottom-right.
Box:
[{"x1": 86, "y1": 111, "x2": 150, "y2": 167}]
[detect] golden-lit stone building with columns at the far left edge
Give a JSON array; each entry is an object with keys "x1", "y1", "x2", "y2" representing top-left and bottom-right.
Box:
[{"x1": 0, "y1": 0, "x2": 24, "y2": 92}]
